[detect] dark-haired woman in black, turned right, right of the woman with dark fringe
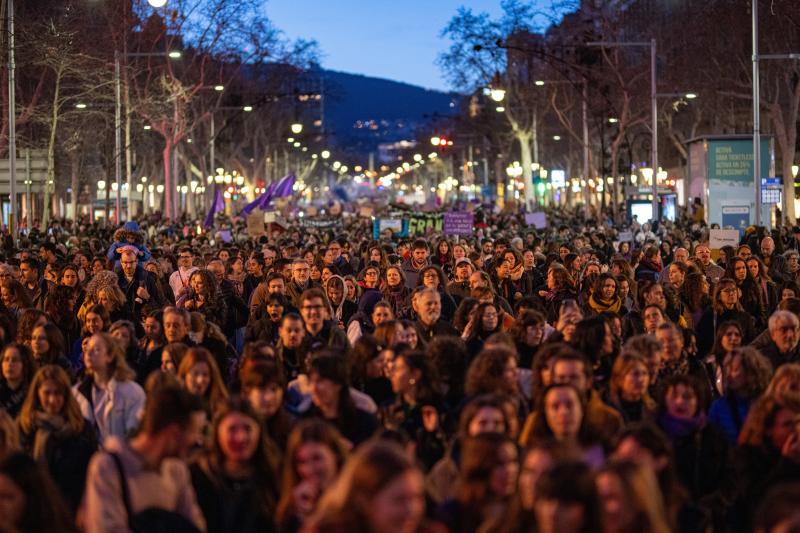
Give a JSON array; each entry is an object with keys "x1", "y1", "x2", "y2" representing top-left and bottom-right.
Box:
[{"x1": 304, "y1": 352, "x2": 378, "y2": 445}]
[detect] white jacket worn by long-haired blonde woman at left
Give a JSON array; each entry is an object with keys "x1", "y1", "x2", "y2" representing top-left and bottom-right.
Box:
[{"x1": 72, "y1": 378, "x2": 145, "y2": 443}]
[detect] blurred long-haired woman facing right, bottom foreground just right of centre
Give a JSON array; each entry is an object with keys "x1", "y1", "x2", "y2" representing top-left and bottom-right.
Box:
[{"x1": 436, "y1": 433, "x2": 519, "y2": 533}]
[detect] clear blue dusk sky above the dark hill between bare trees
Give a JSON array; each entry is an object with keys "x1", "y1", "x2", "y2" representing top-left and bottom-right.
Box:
[{"x1": 267, "y1": 0, "x2": 564, "y2": 90}]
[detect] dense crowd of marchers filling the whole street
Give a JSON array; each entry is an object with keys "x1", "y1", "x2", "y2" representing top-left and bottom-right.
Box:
[{"x1": 0, "y1": 209, "x2": 800, "y2": 533}]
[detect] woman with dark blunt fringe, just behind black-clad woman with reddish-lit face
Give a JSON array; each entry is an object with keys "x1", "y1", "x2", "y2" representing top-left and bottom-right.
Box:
[{"x1": 239, "y1": 358, "x2": 294, "y2": 452}]
